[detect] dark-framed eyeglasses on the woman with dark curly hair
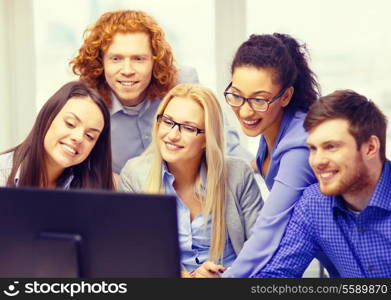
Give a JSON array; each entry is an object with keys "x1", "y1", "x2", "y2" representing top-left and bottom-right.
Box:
[{"x1": 224, "y1": 82, "x2": 286, "y2": 112}]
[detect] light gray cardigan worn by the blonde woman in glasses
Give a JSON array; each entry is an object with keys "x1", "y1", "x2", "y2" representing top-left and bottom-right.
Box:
[{"x1": 119, "y1": 155, "x2": 263, "y2": 254}]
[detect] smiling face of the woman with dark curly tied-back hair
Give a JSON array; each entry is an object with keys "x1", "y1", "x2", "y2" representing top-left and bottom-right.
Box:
[{"x1": 229, "y1": 66, "x2": 290, "y2": 137}]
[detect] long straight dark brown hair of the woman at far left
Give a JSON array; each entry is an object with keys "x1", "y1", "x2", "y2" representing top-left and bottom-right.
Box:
[{"x1": 4, "y1": 81, "x2": 114, "y2": 189}]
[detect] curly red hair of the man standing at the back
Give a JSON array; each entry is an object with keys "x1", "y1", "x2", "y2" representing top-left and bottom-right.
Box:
[{"x1": 70, "y1": 10, "x2": 177, "y2": 107}]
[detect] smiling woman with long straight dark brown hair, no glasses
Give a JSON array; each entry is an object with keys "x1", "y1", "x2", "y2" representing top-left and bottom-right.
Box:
[{"x1": 0, "y1": 81, "x2": 114, "y2": 189}]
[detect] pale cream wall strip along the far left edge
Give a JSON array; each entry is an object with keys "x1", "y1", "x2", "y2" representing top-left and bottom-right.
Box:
[{"x1": 0, "y1": 0, "x2": 36, "y2": 151}]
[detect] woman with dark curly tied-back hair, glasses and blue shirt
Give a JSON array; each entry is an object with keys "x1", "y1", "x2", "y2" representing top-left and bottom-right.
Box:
[{"x1": 220, "y1": 33, "x2": 319, "y2": 277}]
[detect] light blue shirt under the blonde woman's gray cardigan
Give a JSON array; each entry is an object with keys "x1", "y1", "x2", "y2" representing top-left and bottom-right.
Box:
[{"x1": 162, "y1": 163, "x2": 236, "y2": 272}]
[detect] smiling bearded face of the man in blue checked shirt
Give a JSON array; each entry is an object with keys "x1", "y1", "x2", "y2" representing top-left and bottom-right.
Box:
[{"x1": 307, "y1": 119, "x2": 370, "y2": 196}]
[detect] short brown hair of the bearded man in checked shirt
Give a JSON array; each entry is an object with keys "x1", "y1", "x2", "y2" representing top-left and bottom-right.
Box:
[{"x1": 304, "y1": 90, "x2": 387, "y2": 162}]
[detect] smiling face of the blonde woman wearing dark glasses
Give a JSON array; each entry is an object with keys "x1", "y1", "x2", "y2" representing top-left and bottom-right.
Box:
[{"x1": 157, "y1": 97, "x2": 206, "y2": 165}]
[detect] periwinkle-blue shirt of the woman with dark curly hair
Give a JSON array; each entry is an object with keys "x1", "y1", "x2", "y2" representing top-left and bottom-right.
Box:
[{"x1": 223, "y1": 110, "x2": 316, "y2": 277}]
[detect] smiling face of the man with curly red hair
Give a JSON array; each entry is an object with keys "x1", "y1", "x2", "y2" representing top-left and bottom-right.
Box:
[{"x1": 103, "y1": 32, "x2": 153, "y2": 106}]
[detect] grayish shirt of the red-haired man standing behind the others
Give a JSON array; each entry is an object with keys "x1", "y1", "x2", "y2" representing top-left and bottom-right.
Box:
[{"x1": 110, "y1": 68, "x2": 253, "y2": 174}]
